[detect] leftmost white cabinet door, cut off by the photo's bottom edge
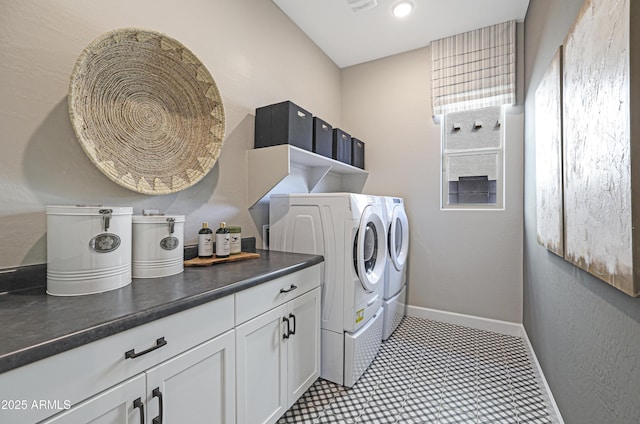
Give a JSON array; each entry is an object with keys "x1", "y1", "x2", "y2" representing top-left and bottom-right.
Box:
[{"x1": 44, "y1": 374, "x2": 146, "y2": 424}]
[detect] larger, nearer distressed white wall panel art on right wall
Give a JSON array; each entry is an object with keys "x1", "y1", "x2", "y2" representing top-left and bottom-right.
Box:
[{"x1": 563, "y1": 0, "x2": 640, "y2": 296}]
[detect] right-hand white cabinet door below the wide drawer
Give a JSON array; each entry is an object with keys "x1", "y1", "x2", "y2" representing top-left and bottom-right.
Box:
[{"x1": 146, "y1": 330, "x2": 235, "y2": 424}]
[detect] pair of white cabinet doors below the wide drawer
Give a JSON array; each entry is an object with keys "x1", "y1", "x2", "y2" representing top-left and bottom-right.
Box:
[{"x1": 46, "y1": 330, "x2": 235, "y2": 424}]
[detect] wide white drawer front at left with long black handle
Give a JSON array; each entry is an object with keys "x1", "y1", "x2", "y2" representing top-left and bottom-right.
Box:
[{"x1": 0, "y1": 296, "x2": 234, "y2": 424}]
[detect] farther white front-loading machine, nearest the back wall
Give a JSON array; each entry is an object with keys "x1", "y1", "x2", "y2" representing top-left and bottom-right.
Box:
[{"x1": 382, "y1": 197, "x2": 409, "y2": 340}]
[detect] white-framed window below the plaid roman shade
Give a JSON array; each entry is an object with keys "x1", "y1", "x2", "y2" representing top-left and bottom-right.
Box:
[{"x1": 441, "y1": 107, "x2": 504, "y2": 209}]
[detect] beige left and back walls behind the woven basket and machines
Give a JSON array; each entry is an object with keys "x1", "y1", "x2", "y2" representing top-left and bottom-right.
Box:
[{"x1": 0, "y1": 0, "x2": 522, "y2": 322}]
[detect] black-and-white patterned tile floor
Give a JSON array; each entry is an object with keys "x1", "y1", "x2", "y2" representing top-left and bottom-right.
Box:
[{"x1": 278, "y1": 317, "x2": 555, "y2": 424}]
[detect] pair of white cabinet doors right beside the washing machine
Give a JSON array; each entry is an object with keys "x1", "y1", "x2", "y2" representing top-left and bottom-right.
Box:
[{"x1": 236, "y1": 287, "x2": 320, "y2": 424}]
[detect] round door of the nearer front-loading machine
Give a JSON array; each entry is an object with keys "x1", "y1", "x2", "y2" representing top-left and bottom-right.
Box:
[{"x1": 353, "y1": 206, "x2": 387, "y2": 292}]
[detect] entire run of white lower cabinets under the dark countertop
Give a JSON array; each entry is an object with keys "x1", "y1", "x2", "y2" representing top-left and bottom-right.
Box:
[{"x1": 0, "y1": 264, "x2": 322, "y2": 424}]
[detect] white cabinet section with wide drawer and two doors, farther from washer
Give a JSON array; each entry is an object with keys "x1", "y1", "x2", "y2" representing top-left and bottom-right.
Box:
[{"x1": 0, "y1": 296, "x2": 235, "y2": 424}]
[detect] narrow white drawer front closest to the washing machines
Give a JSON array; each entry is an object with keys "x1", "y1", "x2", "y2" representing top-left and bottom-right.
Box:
[{"x1": 235, "y1": 264, "x2": 322, "y2": 325}]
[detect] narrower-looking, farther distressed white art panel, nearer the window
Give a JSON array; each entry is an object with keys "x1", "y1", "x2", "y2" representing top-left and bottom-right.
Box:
[{"x1": 535, "y1": 47, "x2": 564, "y2": 256}]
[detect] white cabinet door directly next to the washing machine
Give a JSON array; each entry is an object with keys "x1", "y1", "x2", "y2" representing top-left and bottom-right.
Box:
[{"x1": 287, "y1": 287, "x2": 320, "y2": 406}]
